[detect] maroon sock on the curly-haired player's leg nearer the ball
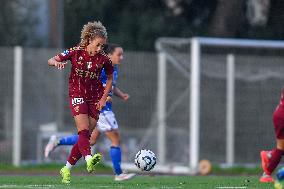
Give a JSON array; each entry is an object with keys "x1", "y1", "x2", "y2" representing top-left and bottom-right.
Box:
[{"x1": 78, "y1": 129, "x2": 91, "y2": 157}]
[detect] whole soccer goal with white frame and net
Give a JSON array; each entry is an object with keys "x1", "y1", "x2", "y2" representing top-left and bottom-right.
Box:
[{"x1": 156, "y1": 38, "x2": 284, "y2": 172}]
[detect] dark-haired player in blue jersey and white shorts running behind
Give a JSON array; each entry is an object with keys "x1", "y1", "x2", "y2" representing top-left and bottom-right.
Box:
[{"x1": 45, "y1": 44, "x2": 135, "y2": 181}]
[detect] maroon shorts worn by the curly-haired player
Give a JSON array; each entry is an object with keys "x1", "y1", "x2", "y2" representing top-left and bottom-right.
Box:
[{"x1": 69, "y1": 97, "x2": 100, "y2": 120}]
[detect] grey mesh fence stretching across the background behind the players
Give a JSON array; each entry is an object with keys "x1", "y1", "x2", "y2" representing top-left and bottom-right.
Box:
[{"x1": 0, "y1": 42, "x2": 284, "y2": 170}]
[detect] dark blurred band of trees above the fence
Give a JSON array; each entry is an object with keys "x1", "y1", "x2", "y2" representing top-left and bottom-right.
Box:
[{"x1": 0, "y1": 0, "x2": 284, "y2": 51}]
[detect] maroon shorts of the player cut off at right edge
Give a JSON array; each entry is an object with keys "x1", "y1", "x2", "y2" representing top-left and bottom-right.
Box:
[{"x1": 273, "y1": 105, "x2": 284, "y2": 139}]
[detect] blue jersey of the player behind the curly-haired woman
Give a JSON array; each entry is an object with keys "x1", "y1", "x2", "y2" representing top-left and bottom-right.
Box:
[{"x1": 101, "y1": 65, "x2": 118, "y2": 112}]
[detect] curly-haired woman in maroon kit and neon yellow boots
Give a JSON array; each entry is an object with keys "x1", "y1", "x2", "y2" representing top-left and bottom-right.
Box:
[{"x1": 48, "y1": 21, "x2": 113, "y2": 184}]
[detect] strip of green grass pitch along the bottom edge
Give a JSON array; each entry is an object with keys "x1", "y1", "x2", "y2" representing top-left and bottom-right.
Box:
[{"x1": 0, "y1": 173, "x2": 273, "y2": 189}]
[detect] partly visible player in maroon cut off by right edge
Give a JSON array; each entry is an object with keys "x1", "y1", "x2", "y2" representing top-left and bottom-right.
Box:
[{"x1": 259, "y1": 89, "x2": 284, "y2": 182}]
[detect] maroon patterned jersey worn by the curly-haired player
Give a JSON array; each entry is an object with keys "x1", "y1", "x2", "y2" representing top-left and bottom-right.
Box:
[{"x1": 58, "y1": 47, "x2": 113, "y2": 100}]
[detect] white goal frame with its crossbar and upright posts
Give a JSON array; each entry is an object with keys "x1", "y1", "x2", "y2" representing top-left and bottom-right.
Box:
[{"x1": 156, "y1": 37, "x2": 284, "y2": 173}]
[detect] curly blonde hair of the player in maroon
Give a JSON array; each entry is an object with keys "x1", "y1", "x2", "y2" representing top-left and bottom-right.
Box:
[{"x1": 80, "y1": 21, "x2": 107, "y2": 47}]
